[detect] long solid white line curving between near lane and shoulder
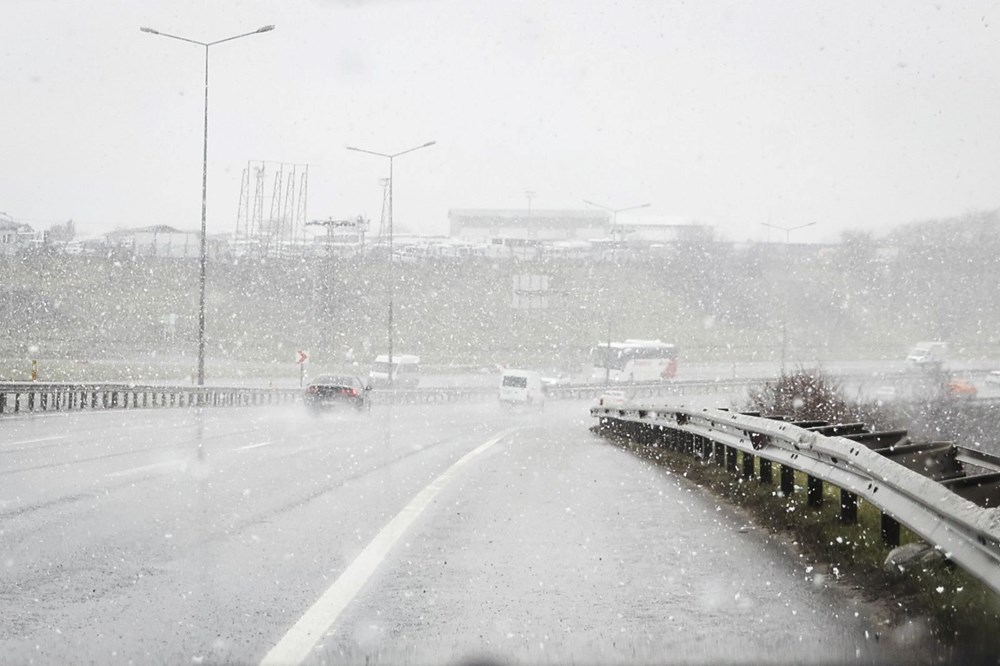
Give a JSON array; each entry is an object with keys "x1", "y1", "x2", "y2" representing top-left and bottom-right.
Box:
[{"x1": 260, "y1": 428, "x2": 517, "y2": 666}]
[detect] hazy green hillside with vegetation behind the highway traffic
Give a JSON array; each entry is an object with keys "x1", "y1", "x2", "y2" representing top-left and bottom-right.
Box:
[{"x1": 0, "y1": 213, "x2": 1000, "y2": 369}]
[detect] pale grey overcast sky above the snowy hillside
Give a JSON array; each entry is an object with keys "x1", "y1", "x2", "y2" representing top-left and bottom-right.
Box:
[{"x1": 0, "y1": 0, "x2": 1000, "y2": 242}]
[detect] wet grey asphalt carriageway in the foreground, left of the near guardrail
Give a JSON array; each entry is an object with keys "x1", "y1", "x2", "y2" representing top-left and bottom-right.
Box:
[{"x1": 0, "y1": 398, "x2": 916, "y2": 664}]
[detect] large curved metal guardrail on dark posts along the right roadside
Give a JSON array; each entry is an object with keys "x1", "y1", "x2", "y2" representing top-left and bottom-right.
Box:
[{"x1": 590, "y1": 403, "x2": 1000, "y2": 593}]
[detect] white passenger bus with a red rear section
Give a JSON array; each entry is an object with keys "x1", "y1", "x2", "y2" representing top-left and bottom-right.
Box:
[{"x1": 590, "y1": 340, "x2": 677, "y2": 382}]
